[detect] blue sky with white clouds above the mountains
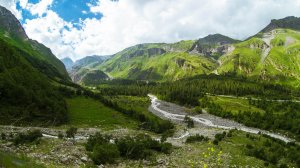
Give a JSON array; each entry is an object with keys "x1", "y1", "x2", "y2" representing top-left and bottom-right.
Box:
[{"x1": 0, "y1": 0, "x2": 300, "y2": 60}]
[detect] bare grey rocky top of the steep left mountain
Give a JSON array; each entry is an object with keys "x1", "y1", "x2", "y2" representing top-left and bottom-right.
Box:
[{"x1": 0, "y1": 6, "x2": 28, "y2": 40}]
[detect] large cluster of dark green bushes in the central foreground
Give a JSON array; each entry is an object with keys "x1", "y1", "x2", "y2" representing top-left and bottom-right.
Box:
[{"x1": 85, "y1": 133, "x2": 172, "y2": 164}]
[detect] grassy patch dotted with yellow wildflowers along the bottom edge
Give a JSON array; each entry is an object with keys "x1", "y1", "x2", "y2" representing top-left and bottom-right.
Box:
[{"x1": 118, "y1": 131, "x2": 265, "y2": 168}]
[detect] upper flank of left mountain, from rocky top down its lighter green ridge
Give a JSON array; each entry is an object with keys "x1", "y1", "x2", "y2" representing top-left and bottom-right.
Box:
[{"x1": 0, "y1": 6, "x2": 70, "y2": 81}]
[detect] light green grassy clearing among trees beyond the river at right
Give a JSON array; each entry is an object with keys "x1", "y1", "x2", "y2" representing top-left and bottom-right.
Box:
[{"x1": 209, "y1": 96, "x2": 264, "y2": 114}]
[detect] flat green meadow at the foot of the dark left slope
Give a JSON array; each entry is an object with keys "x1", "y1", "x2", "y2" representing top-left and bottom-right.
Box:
[{"x1": 67, "y1": 97, "x2": 137, "y2": 129}]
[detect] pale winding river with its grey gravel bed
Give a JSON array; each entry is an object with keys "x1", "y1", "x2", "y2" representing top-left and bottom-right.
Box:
[{"x1": 148, "y1": 94, "x2": 294, "y2": 142}]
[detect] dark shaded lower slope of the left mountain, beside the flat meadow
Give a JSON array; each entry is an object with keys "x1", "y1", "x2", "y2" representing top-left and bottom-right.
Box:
[{"x1": 0, "y1": 39, "x2": 68, "y2": 125}]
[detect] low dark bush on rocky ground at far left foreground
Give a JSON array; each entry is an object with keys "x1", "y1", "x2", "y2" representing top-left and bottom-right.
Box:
[{"x1": 13, "y1": 130, "x2": 43, "y2": 145}]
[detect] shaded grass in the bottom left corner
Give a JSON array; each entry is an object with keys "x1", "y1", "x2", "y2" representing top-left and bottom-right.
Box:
[{"x1": 0, "y1": 151, "x2": 45, "y2": 168}]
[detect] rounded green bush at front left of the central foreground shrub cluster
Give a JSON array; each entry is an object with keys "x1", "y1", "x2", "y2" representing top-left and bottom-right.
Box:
[{"x1": 91, "y1": 143, "x2": 120, "y2": 165}]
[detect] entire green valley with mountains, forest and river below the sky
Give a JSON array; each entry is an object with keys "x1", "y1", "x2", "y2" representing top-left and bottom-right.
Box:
[{"x1": 0, "y1": 2, "x2": 300, "y2": 168}]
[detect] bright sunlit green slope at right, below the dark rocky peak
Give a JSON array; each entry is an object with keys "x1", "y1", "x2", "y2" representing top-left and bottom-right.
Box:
[{"x1": 218, "y1": 29, "x2": 300, "y2": 86}]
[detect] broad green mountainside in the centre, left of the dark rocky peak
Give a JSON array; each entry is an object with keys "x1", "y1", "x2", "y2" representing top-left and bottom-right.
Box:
[{"x1": 97, "y1": 41, "x2": 217, "y2": 81}]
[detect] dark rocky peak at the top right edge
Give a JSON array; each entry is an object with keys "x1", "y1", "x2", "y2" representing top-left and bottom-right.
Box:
[{"x1": 261, "y1": 16, "x2": 300, "y2": 33}]
